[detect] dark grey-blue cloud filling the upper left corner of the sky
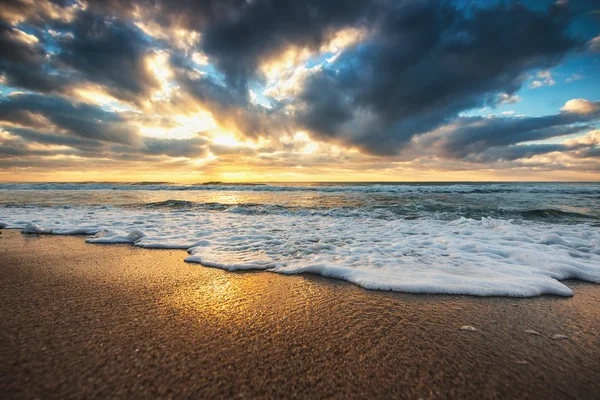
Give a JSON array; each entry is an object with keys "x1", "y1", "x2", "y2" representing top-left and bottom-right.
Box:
[{"x1": 0, "y1": 1, "x2": 158, "y2": 103}]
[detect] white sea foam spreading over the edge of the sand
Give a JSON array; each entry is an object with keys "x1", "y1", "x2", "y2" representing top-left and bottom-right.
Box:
[{"x1": 0, "y1": 206, "x2": 600, "y2": 297}]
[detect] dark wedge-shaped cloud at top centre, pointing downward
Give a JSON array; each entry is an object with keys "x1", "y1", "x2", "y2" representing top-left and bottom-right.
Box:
[{"x1": 88, "y1": 0, "x2": 370, "y2": 85}]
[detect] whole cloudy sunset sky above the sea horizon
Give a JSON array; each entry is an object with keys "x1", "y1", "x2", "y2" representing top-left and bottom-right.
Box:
[{"x1": 0, "y1": 0, "x2": 600, "y2": 182}]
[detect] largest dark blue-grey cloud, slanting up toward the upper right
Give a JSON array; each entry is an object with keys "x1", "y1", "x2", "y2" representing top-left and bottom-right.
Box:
[{"x1": 297, "y1": 1, "x2": 579, "y2": 155}]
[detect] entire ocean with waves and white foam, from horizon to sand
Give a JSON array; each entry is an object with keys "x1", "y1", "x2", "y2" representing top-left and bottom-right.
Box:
[{"x1": 0, "y1": 183, "x2": 600, "y2": 297}]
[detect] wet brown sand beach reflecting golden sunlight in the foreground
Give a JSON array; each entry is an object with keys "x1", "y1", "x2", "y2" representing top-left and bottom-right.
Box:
[{"x1": 0, "y1": 230, "x2": 600, "y2": 399}]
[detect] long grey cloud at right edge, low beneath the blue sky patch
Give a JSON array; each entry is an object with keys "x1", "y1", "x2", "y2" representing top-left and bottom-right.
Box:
[{"x1": 400, "y1": 99, "x2": 600, "y2": 163}]
